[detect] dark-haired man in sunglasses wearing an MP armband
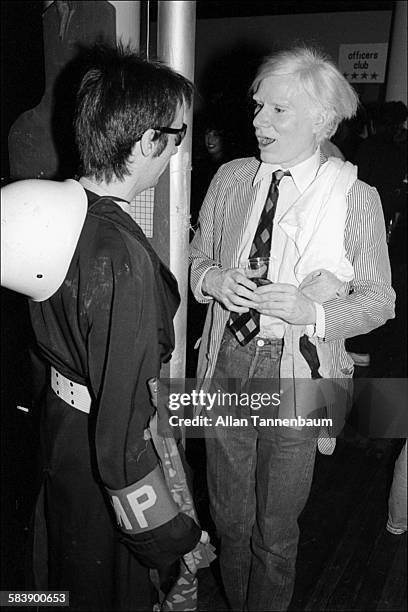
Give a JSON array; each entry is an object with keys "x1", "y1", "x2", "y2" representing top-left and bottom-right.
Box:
[{"x1": 22, "y1": 46, "x2": 202, "y2": 610}]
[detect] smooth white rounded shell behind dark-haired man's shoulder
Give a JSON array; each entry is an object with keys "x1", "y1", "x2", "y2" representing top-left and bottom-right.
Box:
[{"x1": 1, "y1": 179, "x2": 87, "y2": 302}]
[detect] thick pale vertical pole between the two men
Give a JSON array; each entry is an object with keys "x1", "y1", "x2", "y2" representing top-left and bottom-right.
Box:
[{"x1": 157, "y1": 0, "x2": 196, "y2": 378}]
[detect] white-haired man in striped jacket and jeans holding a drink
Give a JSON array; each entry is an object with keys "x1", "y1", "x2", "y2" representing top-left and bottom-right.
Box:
[{"x1": 191, "y1": 47, "x2": 395, "y2": 611}]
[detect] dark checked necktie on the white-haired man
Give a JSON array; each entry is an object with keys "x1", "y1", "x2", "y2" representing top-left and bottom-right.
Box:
[{"x1": 228, "y1": 170, "x2": 290, "y2": 346}]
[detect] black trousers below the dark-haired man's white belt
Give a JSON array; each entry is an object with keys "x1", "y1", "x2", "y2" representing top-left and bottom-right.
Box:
[{"x1": 33, "y1": 389, "x2": 152, "y2": 611}]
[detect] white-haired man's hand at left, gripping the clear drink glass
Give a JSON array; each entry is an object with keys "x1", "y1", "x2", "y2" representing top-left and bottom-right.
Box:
[{"x1": 202, "y1": 268, "x2": 256, "y2": 313}]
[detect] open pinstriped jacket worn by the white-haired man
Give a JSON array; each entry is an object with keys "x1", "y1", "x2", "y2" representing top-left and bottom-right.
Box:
[{"x1": 190, "y1": 158, "x2": 395, "y2": 380}]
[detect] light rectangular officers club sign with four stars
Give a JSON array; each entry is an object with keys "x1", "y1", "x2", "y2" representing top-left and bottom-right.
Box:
[{"x1": 339, "y1": 43, "x2": 388, "y2": 84}]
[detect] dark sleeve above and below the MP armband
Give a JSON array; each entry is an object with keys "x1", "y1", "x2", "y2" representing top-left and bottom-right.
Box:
[{"x1": 83, "y1": 224, "x2": 201, "y2": 567}]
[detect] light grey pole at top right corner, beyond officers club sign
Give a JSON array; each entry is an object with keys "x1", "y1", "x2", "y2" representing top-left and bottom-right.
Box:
[{"x1": 385, "y1": 0, "x2": 407, "y2": 104}]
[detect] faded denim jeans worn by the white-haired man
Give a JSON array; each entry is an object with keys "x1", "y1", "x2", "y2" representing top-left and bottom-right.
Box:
[{"x1": 206, "y1": 329, "x2": 318, "y2": 612}]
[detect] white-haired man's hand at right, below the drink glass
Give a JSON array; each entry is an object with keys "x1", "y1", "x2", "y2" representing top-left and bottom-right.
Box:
[{"x1": 254, "y1": 283, "x2": 316, "y2": 325}]
